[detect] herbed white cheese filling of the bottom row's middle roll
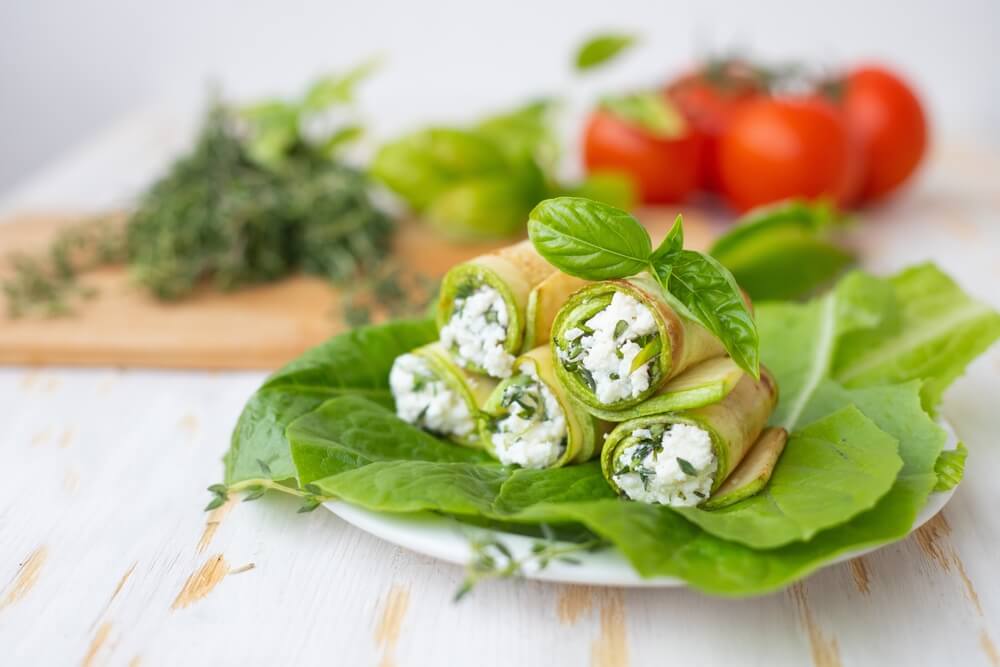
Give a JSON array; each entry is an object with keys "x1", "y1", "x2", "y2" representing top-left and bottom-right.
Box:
[{"x1": 490, "y1": 364, "x2": 567, "y2": 468}]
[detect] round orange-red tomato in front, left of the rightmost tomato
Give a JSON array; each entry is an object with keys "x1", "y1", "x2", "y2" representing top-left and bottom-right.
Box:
[{"x1": 719, "y1": 95, "x2": 862, "y2": 210}]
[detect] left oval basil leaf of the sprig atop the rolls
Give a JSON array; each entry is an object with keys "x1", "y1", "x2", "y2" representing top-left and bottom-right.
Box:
[{"x1": 528, "y1": 197, "x2": 652, "y2": 280}]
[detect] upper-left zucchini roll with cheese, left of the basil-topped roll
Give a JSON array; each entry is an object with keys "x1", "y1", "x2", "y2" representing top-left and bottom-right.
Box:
[{"x1": 437, "y1": 241, "x2": 554, "y2": 378}]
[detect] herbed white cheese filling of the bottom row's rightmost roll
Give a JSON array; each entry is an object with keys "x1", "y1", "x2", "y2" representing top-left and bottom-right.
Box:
[{"x1": 612, "y1": 424, "x2": 719, "y2": 507}]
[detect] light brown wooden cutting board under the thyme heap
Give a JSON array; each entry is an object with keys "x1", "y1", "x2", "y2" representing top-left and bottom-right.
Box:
[{"x1": 0, "y1": 208, "x2": 712, "y2": 369}]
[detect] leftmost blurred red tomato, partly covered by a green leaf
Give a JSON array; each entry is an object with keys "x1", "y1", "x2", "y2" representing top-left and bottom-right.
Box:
[{"x1": 583, "y1": 109, "x2": 702, "y2": 204}]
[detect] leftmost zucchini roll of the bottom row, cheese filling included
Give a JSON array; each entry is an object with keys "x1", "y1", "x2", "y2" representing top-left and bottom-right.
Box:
[{"x1": 389, "y1": 343, "x2": 496, "y2": 447}]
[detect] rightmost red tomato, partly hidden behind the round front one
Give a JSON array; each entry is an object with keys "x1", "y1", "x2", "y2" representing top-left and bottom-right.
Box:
[{"x1": 843, "y1": 66, "x2": 927, "y2": 201}]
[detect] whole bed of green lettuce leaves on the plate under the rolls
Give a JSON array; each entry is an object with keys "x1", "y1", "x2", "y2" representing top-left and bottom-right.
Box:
[{"x1": 221, "y1": 254, "x2": 1000, "y2": 596}]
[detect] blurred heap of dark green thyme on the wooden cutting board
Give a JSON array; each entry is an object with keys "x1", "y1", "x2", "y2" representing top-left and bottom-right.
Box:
[{"x1": 2, "y1": 65, "x2": 422, "y2": 324}]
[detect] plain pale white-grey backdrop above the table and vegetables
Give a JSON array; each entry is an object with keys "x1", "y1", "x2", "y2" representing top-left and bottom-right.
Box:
[{"x1": 0, "y1": 0, "x2": 1000, "y2": 192}]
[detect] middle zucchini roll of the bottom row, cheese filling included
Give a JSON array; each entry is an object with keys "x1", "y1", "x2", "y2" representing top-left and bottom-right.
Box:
[{"x1": 480, "y1": 345, "x2": 607, "y2": 468}]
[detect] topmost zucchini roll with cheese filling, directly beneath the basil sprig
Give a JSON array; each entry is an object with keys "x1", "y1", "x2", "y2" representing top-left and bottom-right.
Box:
[{"x1": 552, "y1": 274, "x2": 725, "y2": 411}]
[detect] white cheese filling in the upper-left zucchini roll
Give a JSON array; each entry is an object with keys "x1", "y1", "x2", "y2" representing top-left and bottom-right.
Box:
[{"x1": 441, "y1": 285, "x2": 514, "y2": 378}]
